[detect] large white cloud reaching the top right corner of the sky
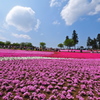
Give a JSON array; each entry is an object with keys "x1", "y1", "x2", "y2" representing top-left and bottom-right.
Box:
[{"x1": 61, "y1": 0, "x2": 100, "y2": 25}]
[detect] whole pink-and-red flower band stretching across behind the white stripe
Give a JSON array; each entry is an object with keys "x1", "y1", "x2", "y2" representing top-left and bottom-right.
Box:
[{"x1": 0, "y1": 49, "x2": 100, "y2": 59}]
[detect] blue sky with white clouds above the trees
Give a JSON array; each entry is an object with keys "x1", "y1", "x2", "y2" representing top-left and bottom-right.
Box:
[{"x1": 0, "y1": 0, "x2": 100, "y2": 48}]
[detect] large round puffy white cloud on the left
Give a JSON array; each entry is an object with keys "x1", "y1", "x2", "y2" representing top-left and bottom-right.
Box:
[{"x1": 6, "y1": 6, "x2": 39, "y2": 32}]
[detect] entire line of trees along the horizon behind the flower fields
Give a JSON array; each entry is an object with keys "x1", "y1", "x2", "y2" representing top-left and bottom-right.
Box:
[{"x1": 0, "y1": 30, "x2": 100, "y2": 50}]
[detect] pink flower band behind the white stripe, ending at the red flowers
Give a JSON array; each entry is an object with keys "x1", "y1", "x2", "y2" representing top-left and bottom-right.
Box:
[{"x1": 0, "y1": 49, "x2": 53, "y2": 57}]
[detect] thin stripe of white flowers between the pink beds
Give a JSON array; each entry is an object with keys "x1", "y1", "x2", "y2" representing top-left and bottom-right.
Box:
[{"x1": 0, "y1": 57, "x2": 73, "y2": 61}]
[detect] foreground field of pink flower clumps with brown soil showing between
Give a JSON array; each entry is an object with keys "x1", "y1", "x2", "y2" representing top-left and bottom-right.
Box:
[{"x1": 0, "y1": 59, "x2": 100, "y2": 100}]
